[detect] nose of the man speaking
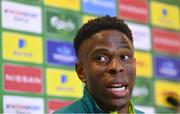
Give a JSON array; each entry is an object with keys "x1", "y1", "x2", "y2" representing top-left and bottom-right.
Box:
[{"x1": 108, "y1": 59, "x2": 124, "y2": 74}]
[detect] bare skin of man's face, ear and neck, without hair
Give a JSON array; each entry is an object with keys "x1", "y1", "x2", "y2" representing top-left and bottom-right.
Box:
[{"x1": 76, "y1": 30, "x2": 136, "y2": 113}]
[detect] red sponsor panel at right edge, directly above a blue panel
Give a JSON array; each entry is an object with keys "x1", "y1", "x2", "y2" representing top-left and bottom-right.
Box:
[{"x1": 152, "y1": 28, "x2": 180, "y2": 54}]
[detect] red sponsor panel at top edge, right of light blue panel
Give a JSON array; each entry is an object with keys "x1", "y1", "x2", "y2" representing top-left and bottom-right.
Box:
[{"x1": 118, "y1": 0, "x2": 149, "y2": 23}]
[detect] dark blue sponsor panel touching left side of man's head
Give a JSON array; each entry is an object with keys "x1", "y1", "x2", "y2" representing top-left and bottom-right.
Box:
[{"x1": 47, "y1": 40, "x2": 77, "y2": 67}]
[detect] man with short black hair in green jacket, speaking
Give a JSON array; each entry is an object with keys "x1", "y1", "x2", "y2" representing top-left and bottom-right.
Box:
[{"x1": 55, "y1": 16, "x2": 142, "y2": 113}]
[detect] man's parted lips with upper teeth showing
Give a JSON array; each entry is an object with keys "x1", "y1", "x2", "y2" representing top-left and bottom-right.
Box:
[{"x1": 106, "y1": 79, "x2": 129, "y2": 97}]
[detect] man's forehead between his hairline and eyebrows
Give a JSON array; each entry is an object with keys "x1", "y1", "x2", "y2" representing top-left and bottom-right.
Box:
[{"x1": 79, "y1": 30, "x2": 133, "y2": 56}]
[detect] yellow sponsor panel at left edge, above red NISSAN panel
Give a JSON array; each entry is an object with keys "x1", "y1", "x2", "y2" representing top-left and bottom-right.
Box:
[{"x1": 2, "y1": 32, "x2": 43, "y2": 64}]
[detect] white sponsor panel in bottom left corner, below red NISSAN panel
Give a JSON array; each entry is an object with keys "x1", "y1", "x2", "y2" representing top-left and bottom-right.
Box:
[{"x1": 3, "y1": 95, "x2": 44, "y2": 114}]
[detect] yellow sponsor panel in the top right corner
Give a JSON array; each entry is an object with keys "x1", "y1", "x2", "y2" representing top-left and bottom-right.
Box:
[{"x1": 150, "y1": 1, "x2": 180, "y2": 30}]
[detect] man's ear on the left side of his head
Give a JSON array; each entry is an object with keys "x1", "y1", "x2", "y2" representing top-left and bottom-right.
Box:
[{"x1": 75, "y1": 61, "x2": 87, "y2": 83}]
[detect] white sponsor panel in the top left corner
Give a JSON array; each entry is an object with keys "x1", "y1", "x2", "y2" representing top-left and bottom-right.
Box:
[{"x1": 2, "y1": 1, "x2": 42, "y2": 33}]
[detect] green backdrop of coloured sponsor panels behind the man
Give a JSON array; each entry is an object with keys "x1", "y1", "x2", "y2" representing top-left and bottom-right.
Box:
[{"x1": 0, "y1": 0, "x2": 180, "y2": 114}]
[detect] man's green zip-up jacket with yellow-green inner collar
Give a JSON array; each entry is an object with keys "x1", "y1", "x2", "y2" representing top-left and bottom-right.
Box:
[{"x1": 53, "y1": 87, "x2": 144, "y2": 114}]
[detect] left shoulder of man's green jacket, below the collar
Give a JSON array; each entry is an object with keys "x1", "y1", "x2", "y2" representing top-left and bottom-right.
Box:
[{"x1": 53, "y1": 100, "x2": 85, "y2": 114}]
